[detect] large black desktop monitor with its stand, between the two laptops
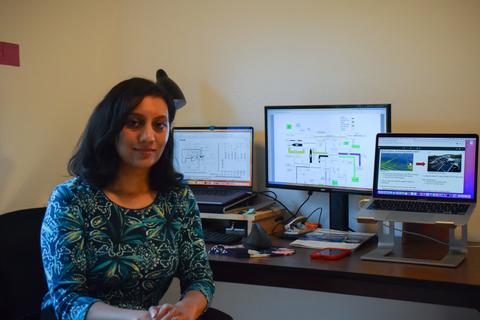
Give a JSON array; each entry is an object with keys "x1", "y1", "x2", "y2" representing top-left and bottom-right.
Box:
[{"x1": 265, "y1": 104, "x2": 391, "y2": 230}]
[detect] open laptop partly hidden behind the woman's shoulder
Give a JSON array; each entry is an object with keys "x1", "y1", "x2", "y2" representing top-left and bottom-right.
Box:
[{"x1": 173, "y1": 127, "x2": 253, "y2": 212}]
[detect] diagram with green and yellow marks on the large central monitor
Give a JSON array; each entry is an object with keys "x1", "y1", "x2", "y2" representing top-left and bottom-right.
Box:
[{"x1": 274, "y1": 116, "x2": 379, "y2": 188}]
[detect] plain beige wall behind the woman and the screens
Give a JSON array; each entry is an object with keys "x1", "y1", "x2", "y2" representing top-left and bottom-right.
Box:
[{"x1": 0, "y1": 0, "x2": 480, "y2": 240}]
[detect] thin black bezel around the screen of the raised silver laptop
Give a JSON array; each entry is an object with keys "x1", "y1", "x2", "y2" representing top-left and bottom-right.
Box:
[{"x1": 372, "y1": 133, "x2": 479, "y2": 203}]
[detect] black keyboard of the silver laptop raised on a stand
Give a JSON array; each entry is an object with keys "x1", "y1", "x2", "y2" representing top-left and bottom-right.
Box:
[{"x1": 368, "y1": 200, "x2": 469, "y2": 214}]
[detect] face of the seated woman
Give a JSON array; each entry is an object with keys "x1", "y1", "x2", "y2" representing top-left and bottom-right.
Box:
[{"x1": 116, "y1": 96, "x2": 170, "y2": 170}]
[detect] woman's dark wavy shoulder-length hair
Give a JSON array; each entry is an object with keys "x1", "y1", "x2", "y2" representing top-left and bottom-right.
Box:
[{"x1": 68, "y1": 78, "x2": 183, "y2": 193}]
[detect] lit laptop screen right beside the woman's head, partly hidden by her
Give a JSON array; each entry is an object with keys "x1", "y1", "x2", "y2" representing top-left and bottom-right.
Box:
[{"x1": 173, "y1": 127, "x2": 253, "y2": 187}]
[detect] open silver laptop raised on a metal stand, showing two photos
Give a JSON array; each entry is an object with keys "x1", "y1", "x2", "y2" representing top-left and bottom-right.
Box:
[{"x1": 357, "y1": 133, "x2": 478, "y2": 225}]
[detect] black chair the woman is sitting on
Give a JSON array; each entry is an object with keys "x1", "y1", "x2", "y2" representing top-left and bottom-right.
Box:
[{"x1": 0, "y1": 207, "x2": 233, "y2": 320}]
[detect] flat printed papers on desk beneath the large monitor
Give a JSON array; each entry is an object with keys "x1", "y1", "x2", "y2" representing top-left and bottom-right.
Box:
[{"x1": 290, "y1": 229, "x2": 375, "y2": 250}]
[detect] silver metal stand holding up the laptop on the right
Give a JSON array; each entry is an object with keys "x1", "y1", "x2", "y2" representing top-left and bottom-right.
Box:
[{"x1": 361, "y1": 221, "x2": 467, "y2": 267}]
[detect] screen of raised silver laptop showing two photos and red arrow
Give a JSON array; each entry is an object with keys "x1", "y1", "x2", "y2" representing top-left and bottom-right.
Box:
[{"x1": 373, "y1": 134, "x2": 478, "y2": 202}]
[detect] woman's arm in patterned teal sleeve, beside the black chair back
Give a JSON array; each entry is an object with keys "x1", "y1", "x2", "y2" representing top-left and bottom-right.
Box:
[{"x1": 40, "y1": 183, "x2": 97, "y2": 320}]
